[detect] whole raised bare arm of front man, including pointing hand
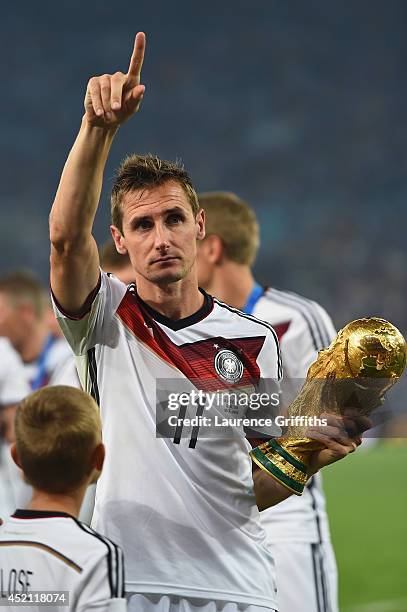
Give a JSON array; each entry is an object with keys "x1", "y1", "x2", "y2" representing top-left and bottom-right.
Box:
[{"x1": 50, "y1": 32, "x2": 145, "y2": 315}]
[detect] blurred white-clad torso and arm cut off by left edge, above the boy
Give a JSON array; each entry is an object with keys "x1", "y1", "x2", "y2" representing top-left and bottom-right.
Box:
[{"x1": 0, "y1": 337, "x2": 30, "y2": 518}]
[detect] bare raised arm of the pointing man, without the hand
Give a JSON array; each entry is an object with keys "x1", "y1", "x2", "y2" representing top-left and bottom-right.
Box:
[{"x1": 50, "y1": 118, "x2": 117, "y2": 315}]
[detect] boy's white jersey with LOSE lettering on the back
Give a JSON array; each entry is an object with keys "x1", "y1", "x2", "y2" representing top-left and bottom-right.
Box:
[{"x1": 0, "y1": 510, "x2": 126, "y2": 612}]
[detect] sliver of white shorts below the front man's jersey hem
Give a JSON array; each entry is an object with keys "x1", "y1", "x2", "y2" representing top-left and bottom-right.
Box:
[{"x1": 127, "y1": 593, "x2": 276, "y2": 612}]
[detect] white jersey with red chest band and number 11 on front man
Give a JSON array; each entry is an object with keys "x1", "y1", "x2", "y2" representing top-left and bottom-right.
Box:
[{"x1": 52, "y1": 273, "x2": 281, "y2": 609}]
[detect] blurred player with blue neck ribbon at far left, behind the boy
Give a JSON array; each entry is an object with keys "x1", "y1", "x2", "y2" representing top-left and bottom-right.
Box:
[{"x1": 0, "y1": 271, "x2": 72, "y2": 391}]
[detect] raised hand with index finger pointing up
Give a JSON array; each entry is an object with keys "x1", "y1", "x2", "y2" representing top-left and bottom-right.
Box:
[{"x1": 84, "y1": 32, "x2": 146, "y2": 128}]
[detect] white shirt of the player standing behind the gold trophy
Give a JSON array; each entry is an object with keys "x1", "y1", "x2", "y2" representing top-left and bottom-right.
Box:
[{"x1": 253, "y1": 289, "x2": 336, "y2": 543}]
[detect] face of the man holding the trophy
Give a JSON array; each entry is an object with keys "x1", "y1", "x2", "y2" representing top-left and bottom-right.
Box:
[{"x1": 111, "y1": 181, "x2": 205, "y2": 285}]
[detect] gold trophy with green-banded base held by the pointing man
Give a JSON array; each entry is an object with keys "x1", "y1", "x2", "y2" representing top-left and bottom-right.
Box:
[{"x1": 250, "y1": 317, "x2": 406, "y2": 495}]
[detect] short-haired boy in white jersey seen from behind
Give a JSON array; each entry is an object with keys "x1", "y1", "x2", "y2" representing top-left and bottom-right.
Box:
[{"x1": 0, "y1": 386, "x2": 127, "y2": 612}]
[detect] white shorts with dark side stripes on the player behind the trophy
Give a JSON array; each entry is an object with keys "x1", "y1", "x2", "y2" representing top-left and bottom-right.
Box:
[{"x1": 268, "y1": 542, "x2": 338, "y2": 612}]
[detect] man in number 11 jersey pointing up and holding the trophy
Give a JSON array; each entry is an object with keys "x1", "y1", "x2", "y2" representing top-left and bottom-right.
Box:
[{"x1": 50, "y1": 33, "x2": 359, "y2": 612}]
